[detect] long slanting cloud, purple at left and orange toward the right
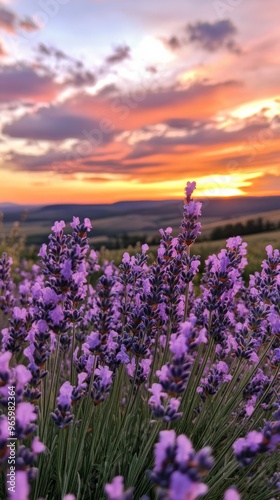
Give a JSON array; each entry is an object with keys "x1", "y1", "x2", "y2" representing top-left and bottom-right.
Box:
[{"x1": 0, "y1": 76, "x2": 242, "y2": 141}]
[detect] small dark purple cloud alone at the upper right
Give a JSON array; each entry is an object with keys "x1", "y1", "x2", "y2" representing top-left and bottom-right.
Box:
[{"x1": 186, "y1": 19, "x2": 240, "y2": 53}]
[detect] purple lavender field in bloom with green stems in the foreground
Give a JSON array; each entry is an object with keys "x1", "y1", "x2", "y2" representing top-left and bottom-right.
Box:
[{"x1": 0, "y1": 182, "x2": 280, "y2": 500}]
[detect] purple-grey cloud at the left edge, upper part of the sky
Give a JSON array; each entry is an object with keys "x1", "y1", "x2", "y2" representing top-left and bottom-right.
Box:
[{"x1": 0, "y1": 63, "x2": 62, "y2": 103}]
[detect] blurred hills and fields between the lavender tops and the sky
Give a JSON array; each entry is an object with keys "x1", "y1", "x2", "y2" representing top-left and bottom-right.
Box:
[{"x1": 0, "y1": 197, "x2": 280, "y2": 281}]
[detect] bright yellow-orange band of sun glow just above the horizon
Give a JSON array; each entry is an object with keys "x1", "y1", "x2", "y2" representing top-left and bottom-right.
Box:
[{"x1": 0, "y1": 172, "x2": 262, "y2": 205}]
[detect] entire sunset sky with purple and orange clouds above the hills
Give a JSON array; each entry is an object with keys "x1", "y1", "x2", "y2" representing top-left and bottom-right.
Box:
[{"x1": 0, "y1": 0, "x2": 280, "y2": 204}]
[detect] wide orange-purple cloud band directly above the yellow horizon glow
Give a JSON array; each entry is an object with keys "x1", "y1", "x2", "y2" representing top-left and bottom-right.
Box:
[{"x1": 8, "y1": 107, "x2": 279, "y2": 183}]
